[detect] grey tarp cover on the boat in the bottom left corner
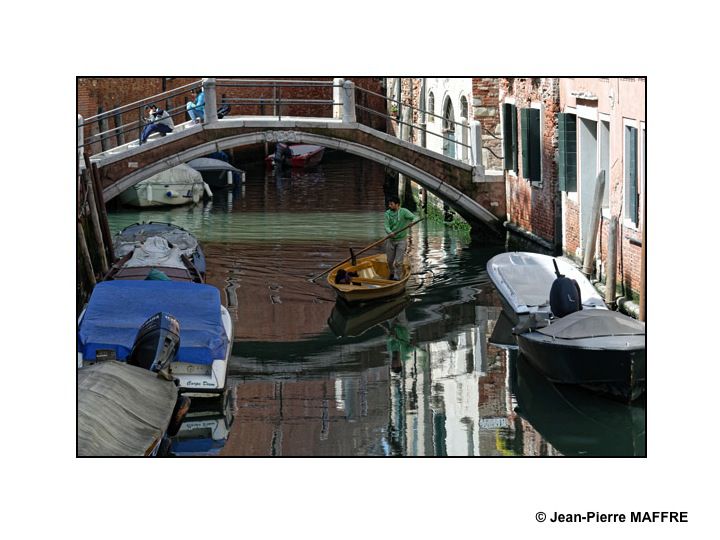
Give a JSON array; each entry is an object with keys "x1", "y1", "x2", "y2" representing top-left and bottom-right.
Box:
[{"x1": 77, "y1": 361, "x2": 178, "y2": 456}]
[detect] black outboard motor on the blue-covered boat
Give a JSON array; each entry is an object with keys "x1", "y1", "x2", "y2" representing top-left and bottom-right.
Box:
[{"x1": 128, "y1": 312, "x2": 180, "y2": 381}]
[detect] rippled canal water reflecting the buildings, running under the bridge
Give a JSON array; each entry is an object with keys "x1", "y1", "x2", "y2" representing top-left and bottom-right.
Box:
[{"x1": 109, "y1": 153, "x2": 646, "y2": 456}]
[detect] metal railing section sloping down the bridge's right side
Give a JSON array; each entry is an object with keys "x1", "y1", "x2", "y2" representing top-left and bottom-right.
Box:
[{"x1": 356, "y1": 87, "x2": 482, "y2": 165}]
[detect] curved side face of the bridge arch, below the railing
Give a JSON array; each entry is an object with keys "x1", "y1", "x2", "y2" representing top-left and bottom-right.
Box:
[{"x1": 101, "y1": 130, "x2": 501, "y2": 237}]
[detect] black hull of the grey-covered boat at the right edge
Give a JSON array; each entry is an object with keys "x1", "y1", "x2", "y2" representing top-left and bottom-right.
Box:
[{"x1": 517, "y1": 332, "x2": 647, "y2": 403}]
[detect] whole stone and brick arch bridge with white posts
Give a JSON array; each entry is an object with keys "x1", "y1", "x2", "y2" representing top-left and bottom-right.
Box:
[{"x1": 80, "y1": 80, "x2": 505, "y2": 236}]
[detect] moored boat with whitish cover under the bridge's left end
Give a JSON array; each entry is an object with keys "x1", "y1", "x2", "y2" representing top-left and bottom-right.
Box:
[{"x1": 119, "y1": 164, "x2": 205, "y2": 207}]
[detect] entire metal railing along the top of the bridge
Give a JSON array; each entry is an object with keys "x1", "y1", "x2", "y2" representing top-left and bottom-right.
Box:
[{"x1": 78, "y1": 78, "x2": 481, "y2": 169}]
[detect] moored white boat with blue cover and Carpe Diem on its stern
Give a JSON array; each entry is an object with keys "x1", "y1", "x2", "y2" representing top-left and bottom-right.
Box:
[{"x1": 78, "y1": 280, "x2": 233, "y2": 395}]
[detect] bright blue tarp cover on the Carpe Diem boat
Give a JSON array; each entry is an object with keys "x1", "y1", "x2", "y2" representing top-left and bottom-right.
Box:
[{"x1": 78, "y1": 280, "x2": 228, "y2": 364}]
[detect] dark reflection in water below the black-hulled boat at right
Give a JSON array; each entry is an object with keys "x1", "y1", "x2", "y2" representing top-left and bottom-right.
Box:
[{"x1": 514, "y1": 355, "x2": 646, "y2": 456}]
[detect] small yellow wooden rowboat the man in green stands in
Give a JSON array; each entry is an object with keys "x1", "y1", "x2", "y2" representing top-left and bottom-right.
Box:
[{"x1": 327, "y1": 253, "x2": 410, "y2": 303}]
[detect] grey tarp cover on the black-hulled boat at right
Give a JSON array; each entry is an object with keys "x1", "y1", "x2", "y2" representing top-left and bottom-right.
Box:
[{"x1": 537, "y1": 309, "x2": 645, "y2": 339}]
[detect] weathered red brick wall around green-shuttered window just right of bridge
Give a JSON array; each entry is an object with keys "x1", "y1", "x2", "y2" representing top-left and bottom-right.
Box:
[{"x1": 498, "y1": 78, "x2": 559, "y2": 244}]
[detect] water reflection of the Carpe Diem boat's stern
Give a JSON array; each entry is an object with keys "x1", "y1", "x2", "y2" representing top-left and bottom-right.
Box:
[{"x1": 170, "y1": 391, "x2": 234, "y2": 457}]
